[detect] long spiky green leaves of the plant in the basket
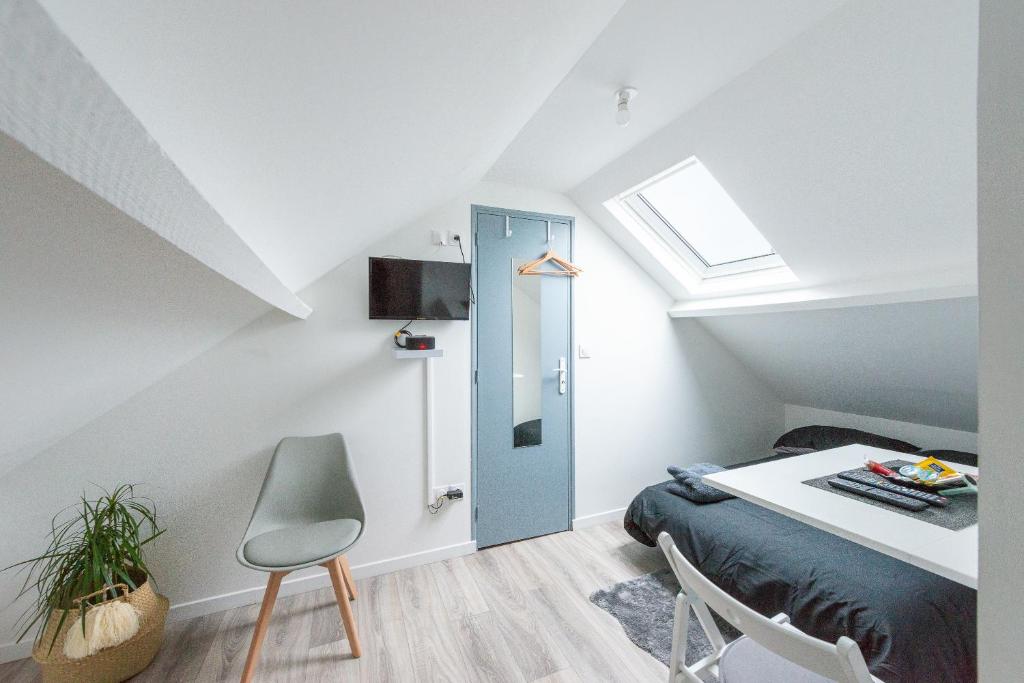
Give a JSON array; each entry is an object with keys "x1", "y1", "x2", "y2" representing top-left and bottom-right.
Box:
[{"x1": 3, "y1": 484, "x2": 165, "y2": 651}]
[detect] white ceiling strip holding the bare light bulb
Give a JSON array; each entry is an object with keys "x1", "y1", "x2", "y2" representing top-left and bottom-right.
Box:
[{"x1": 487, "y1": 0, "x2": 845, "y2": 191}]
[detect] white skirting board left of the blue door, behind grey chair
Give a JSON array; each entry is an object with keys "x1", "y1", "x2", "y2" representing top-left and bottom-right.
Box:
[{"x1": 0, "y1": 541, "x2": 476, "y2": 664}]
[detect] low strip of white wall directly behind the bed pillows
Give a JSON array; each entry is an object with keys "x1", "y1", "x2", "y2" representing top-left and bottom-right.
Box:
[{"x1": 785, "y1": 403, "x2": 978, "y2": 453}]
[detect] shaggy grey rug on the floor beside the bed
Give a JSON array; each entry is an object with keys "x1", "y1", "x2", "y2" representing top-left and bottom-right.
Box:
[{"x1": 590, "y1": 569, "x2": 739, "y2": 666}]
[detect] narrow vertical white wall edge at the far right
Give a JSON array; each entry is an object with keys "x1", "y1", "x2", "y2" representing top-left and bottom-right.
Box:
[{"x1": 978, "y1": 0, "x2": 1024, "y2": 683}]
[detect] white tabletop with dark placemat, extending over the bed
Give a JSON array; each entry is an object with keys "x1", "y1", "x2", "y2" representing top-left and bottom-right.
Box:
[{"x1": 703, "y1": 445, "x2": 978, "y2": 588}]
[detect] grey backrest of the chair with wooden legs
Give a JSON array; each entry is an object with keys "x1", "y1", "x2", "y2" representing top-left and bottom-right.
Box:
[{"x1": 242, "y1": 434, "x2": 366, "y2": 546}]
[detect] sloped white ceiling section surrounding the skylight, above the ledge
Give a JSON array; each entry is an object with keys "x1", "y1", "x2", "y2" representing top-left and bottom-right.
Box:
[{"x1": 569, "y1": 0, "x2": 978, "y2": 299}]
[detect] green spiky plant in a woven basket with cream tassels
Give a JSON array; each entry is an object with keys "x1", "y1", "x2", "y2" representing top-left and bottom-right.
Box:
[{"x1": 4, "y1": 484, "x2": 168, "y2": 682}]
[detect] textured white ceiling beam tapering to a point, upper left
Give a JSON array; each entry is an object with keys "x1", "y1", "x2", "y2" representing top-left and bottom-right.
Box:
[{"x1": 0, "y1": 0, "x2": 312, "y2": 318}]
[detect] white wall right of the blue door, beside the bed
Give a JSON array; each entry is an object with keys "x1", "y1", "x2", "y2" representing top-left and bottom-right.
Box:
[{"x1": 569, "y1": 188, "x2": 783, "y2": 520}]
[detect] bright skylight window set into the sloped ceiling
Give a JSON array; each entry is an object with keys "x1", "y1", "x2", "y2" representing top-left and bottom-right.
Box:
[{"x1": 618, "y1": 157, "x2": 785, "y2": 280}]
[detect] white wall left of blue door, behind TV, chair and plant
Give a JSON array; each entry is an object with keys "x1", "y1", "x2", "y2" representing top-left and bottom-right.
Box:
[{"x1": 0, "y1": 198, "x2": 470, "y2": 663}]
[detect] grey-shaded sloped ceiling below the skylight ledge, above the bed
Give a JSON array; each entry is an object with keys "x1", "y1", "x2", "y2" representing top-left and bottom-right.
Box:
[{"x1": 701, "y1": 297, "x2": 978, "y2": 431}]
